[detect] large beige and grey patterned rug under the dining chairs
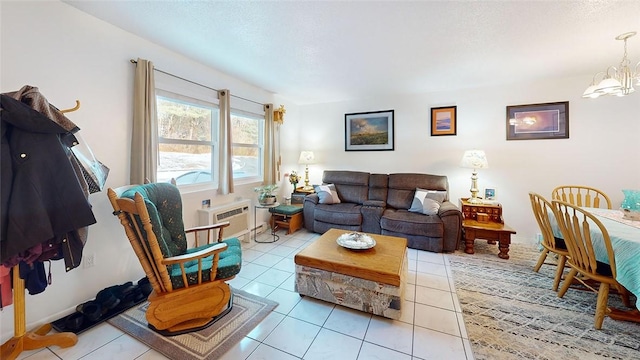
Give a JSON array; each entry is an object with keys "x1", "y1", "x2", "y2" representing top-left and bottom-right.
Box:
[{"x1": 448, "y1": 241, "x2": 640, "y2": 360}]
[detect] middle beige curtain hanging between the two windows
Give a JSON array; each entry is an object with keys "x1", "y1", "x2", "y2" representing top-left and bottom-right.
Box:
[{"x1": 218, "y1": 89, "x2": 233, "y2": 195}]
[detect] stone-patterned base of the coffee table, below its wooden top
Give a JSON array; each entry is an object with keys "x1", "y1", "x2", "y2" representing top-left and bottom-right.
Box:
[{"x1": 295, "y1": 258, "x2": 407, "y2": 320}]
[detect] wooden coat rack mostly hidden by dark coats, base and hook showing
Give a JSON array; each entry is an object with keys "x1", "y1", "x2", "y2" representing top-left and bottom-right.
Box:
[{"x1": 0, "y1": 100, "x2": 80, "y2": 360}]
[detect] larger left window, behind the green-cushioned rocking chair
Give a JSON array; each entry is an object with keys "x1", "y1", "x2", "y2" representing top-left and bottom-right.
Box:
[{"x1": 156, "y1": 89, "x2": 219, "y2": 186}]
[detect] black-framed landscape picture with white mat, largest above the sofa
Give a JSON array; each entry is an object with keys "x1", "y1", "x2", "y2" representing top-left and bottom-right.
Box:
[{"x1": 344, "y1": 110, "x2": 394, "y2": 151}]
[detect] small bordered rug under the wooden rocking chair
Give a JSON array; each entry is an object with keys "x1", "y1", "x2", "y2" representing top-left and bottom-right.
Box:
[{"x1": 108, "y1": 289, "x2": 278, "y2": 360}]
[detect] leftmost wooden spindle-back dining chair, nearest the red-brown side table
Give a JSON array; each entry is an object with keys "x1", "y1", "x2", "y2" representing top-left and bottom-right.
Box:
[{"x1": 529, "y1": 192, "x2": 569, "y2": 291}]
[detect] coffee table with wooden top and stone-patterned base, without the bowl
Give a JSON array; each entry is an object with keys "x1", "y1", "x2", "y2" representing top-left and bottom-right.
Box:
[{"x1": 294, "y1": 229, "x2": 407, "y2": 319}]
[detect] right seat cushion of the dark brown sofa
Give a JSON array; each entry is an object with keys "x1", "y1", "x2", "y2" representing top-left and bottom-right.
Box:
[{"x1": 380, "y1": 209, "x2": 444, "y2": 238}]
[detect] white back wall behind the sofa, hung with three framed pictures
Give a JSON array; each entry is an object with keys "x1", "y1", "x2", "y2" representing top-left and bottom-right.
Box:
[{"x1": 299, "y1": 80, "x2": 640, "y2": 245}]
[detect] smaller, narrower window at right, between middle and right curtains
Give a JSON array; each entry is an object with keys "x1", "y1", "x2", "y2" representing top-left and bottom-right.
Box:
[{"x1": 231, "y1": 109, "x2": 264, "y2": 181}]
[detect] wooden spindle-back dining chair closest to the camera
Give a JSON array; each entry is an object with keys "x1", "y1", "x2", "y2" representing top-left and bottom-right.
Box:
[{"x1": 552, "y1": 200, "x2": 631, "y2": 329}]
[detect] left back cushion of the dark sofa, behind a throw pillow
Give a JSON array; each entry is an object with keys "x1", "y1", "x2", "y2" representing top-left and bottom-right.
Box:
[{"x1": 322, "y1": 170, "x2": 369, "y2": 204}]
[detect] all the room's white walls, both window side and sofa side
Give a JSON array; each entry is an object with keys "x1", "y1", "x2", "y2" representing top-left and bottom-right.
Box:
[{"x1": 0, "y1": 2, "x2": 640, "y2": 342}]
